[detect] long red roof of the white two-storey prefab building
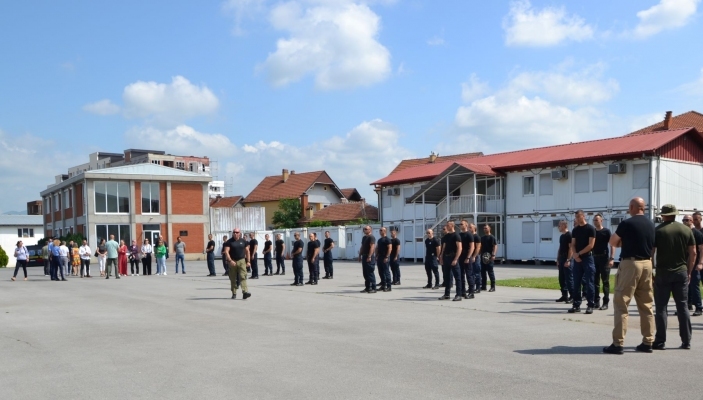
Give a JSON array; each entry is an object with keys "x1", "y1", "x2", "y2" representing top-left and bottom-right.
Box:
[{"x1": 372, "y1": 127, "x2": 703, "y2": 185}]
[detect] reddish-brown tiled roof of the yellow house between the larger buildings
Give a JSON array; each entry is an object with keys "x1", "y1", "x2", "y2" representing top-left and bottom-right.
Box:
[{"x1": 244, "y1": 171, "x2": 341, "y2": 203}]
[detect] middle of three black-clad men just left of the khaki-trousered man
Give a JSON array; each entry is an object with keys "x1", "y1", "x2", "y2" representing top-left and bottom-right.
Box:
[{"x1": 569, "y1": 210, "x2": 596, "y2": 314}]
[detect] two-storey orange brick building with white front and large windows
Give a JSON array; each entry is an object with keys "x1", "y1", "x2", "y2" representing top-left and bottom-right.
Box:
[{"x1": 41, "y1": 163, "x2": 212, "y2": 259}]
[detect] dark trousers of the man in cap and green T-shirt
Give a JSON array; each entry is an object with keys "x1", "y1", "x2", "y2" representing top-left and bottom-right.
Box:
[{"x1": 654, "y1": 271, "x2": 692, "y2": 343}]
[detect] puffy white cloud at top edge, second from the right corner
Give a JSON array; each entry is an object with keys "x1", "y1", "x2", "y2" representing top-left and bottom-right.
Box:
[{"x1": 503, "y1": 0, "x2": 594, "y2": 47}]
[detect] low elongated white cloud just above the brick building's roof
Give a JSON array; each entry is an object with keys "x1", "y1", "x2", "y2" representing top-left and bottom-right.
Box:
[{"x1": 125, "y1": 125, "x2": 238, "y2": 158}]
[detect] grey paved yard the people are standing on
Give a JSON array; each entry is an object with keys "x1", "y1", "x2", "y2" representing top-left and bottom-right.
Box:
[{"x1": 0, "y1": 262, "x2": 703, "y2": 399}]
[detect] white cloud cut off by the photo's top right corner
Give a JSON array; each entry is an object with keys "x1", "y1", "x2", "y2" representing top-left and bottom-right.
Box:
[{"x1": 632, "y1": 0, "x2": 700, "y2": 38}]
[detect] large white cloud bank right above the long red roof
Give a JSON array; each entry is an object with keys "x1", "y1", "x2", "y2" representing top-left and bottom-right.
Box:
[{"x1": 452, "y1": 65, "x2": 618, "y2": 153}]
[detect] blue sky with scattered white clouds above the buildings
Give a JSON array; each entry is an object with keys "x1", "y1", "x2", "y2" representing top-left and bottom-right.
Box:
[{"x1": 0, "y1": 0, "x2": 703, "y2": 212}]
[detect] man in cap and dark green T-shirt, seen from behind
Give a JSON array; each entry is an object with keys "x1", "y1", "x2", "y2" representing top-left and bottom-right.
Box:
[{"x1": 644, "y1": 204, "x2": 696, "y2": 352}]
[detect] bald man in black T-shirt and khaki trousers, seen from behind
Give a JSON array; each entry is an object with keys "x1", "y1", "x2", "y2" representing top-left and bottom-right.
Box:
[{"x1": 603, "y1": 197, "x2": 654, "y2": 354}]
